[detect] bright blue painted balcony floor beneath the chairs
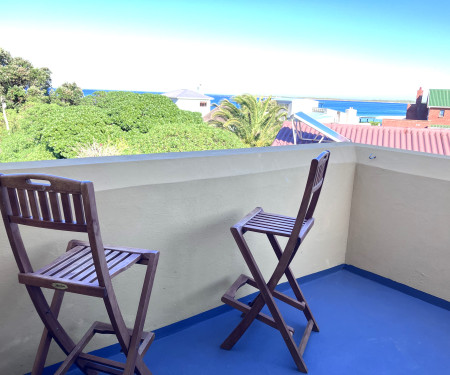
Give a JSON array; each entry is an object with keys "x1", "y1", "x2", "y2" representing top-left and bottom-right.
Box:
[{"x1": 61, "y1": 270, "x2": 450, "y2": 375}]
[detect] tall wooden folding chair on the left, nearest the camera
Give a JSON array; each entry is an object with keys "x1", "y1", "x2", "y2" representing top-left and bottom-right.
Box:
[{"x1": 0, "y1": 174, "x2": 159, "y2": 375}]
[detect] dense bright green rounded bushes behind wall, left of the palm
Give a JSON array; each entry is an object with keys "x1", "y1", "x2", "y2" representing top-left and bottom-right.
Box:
[{"x1": 0, "y1": 92, "x2": 246, "y2": 162}]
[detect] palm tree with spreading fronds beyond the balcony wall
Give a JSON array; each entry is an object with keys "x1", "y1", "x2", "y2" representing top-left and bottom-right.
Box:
[{"x1": 208, "y1": 94, "x2": 286, "y2": 147}]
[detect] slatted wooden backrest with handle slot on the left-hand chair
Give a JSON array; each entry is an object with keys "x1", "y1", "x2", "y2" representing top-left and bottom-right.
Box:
[{"x1": 0, "y1": 174, "x2": 109, "y2": 285}]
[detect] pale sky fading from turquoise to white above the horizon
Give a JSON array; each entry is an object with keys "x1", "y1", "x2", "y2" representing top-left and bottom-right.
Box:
[{"x1": 0, "y1": 0, "x2": 450, "y2": 100}]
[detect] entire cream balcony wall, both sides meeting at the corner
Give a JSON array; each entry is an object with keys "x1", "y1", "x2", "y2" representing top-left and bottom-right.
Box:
[{"x1": 0, "y1": 144, "x2": 450, "y2": 374}]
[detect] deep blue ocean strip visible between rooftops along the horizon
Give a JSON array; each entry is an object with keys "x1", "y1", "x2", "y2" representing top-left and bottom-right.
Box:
[{"x1": 83, "y1": 90, "x2": 407, "y2": 119}]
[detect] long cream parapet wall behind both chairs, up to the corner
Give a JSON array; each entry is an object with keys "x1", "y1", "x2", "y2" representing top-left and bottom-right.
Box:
[{"x1": 0, "y1": 144, "x2": 355, "y2": 374}]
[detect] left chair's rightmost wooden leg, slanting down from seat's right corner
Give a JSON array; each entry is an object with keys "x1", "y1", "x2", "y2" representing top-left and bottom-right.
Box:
[{"x1": 124, "y1": 253, "x2": 159, "y2": 375}]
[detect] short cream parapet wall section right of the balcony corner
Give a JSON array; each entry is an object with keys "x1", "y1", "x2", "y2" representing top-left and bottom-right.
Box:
[{"x1": 346, "y1": 145, "x2": 450, "y2": 301}]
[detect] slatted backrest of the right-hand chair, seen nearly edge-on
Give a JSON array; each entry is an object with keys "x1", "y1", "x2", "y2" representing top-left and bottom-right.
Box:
[{"x1": 286, "y1": 151, "x2": 330, "y2": 248}]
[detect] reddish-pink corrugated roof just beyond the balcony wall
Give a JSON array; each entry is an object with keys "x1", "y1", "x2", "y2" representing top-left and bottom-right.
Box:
[{"x1": 272, "y1": 121, "x2": 450, "y2": 156}]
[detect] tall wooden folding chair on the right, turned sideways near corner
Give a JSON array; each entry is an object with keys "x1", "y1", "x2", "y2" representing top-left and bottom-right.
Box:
[{"x1": 221, "y1": 151, "x2": 330, "y2": 372}]
